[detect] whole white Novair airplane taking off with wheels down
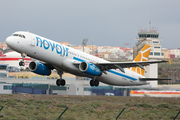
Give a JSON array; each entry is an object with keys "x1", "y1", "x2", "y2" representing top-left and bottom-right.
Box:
[{"x1": 6, "y1": 31, "x2": 171, "y2": 86}]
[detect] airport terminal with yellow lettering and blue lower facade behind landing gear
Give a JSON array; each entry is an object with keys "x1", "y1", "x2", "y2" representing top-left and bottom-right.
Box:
[{"x1": 0, "y1": 72, "x2": 141, "y2": 96}]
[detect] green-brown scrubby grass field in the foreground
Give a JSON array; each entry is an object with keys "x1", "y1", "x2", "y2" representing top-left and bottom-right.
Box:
[{"x1": 0, "y1": 95, "x2": 180, "y2": 120}]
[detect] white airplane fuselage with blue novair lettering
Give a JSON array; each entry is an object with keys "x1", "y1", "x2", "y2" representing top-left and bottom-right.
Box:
[{"x1": 6, "y1": 32, "x2": 147, "y2": 86}]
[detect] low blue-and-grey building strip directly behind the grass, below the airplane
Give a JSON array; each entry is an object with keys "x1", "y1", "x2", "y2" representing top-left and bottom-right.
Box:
[{"x1": 0, "y1": 79, "x2": 130, "y2": 96}]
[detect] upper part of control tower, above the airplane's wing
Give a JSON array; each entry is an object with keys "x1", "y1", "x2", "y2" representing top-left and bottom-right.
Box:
[{"x1": 133, "y1": 28, "x2": 164, "y2": 59}]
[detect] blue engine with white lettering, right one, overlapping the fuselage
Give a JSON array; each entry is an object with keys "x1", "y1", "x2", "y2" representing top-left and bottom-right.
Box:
[{"x1": 79, "y1": 61, "x2": 102, "y2": 76}]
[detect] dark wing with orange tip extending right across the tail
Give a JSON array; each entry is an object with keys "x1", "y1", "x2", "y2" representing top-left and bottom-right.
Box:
[{"x1": 95, "y1": 60, "x2": 171, "y2": 72}]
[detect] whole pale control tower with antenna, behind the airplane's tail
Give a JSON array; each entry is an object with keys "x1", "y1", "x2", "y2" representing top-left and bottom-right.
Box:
[{"x1": 133, "y1": 23, "x2": 164, "y2": 87}]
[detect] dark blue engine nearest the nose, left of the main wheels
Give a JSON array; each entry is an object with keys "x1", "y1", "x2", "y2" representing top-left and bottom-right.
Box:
[{"x1": 29, "y1": 61, "x2": 51, "y2": 75}]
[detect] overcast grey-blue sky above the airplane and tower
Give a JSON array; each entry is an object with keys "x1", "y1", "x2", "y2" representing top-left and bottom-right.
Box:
[{"x1": 0, "y1": 0, "x2": 180, "y2": 49}]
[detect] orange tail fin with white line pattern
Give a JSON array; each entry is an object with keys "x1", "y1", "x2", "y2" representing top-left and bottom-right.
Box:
[{"x1": 130, "y1": 44, "x2": 151, "y2": 75}]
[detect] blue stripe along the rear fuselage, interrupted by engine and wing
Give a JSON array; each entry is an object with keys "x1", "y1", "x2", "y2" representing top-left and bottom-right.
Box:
[{"x1": 73, "y1": 57, "x2": 137, "y2": 81}]
